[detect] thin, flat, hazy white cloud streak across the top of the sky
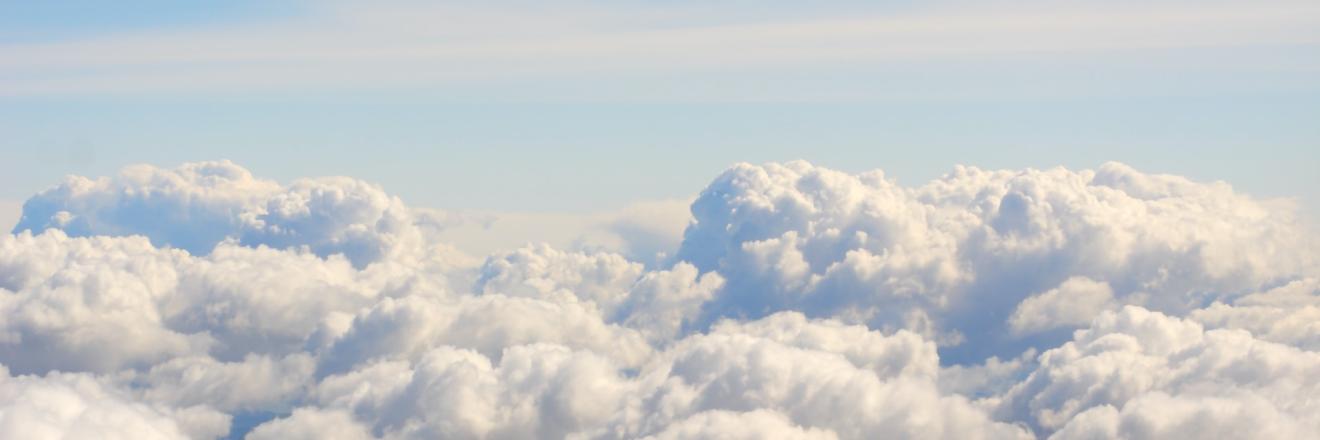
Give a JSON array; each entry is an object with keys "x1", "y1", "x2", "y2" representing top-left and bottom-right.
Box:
[{"x1": 0, "y1": 0, "x2": 1320, "y2": 95}]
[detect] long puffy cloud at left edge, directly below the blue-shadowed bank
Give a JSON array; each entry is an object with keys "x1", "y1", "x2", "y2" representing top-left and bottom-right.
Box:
[{"x1": 0, "y1": 225, "x2": 459, "y2": 373}]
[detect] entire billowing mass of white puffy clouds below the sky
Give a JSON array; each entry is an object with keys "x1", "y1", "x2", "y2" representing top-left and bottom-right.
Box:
[{"x1": 0, "y1": 161, "x2": 1320, "y2": 439}]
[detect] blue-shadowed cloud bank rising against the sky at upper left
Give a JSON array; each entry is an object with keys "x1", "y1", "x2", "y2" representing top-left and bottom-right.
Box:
[{"x1": 15, "y1": 161, "x2": 438, "y2": 267}]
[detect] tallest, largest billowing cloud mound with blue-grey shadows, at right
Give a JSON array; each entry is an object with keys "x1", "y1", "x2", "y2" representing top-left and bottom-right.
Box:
[{"x1": 677, "y1": 163, "x2": 1317, "y2": 362}]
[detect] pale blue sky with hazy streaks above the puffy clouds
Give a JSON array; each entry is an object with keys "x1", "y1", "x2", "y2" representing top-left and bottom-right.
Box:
[{"x1": 0, "y1": 0, "x2": 1320, "y2": 211}]
